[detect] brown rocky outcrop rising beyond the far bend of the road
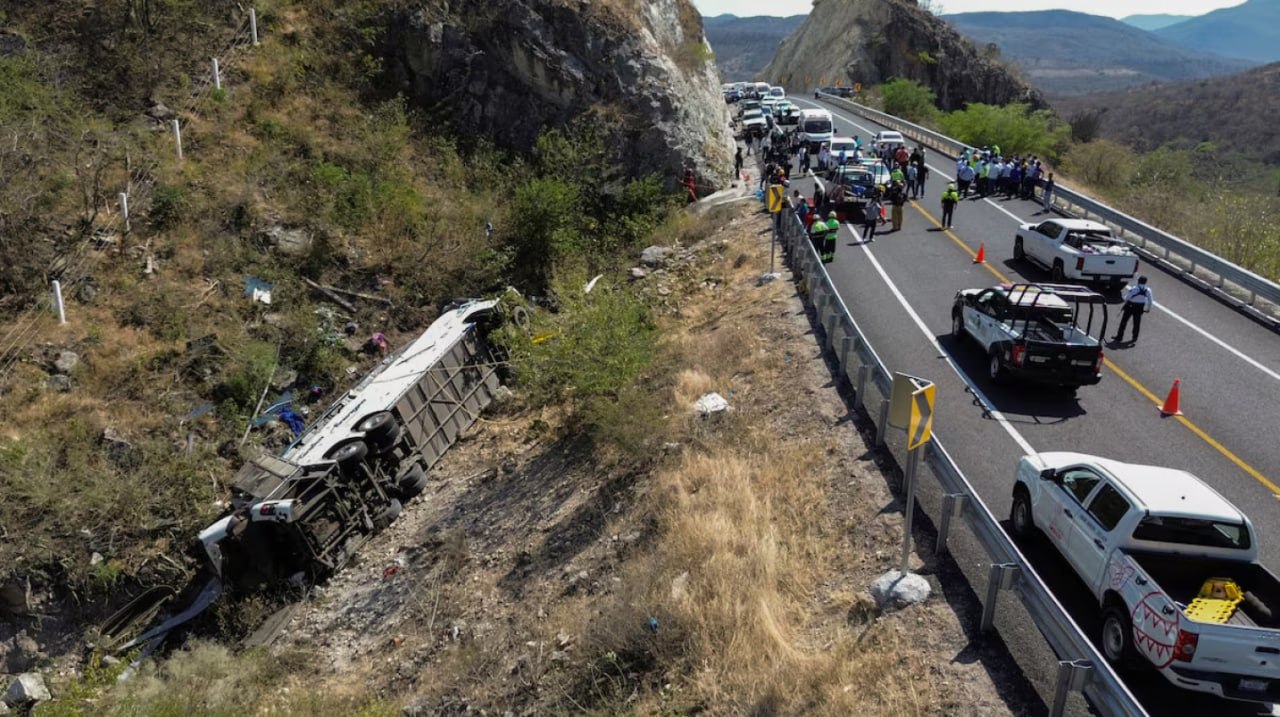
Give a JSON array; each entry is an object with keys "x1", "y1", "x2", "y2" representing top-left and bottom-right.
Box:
[{"x1": 764, "y1": 0, "x2": 1041, "y2": 110}]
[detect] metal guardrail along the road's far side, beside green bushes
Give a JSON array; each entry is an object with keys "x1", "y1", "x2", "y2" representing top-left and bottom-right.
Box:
[{"x1": 819, "y1": 92, "x2": 1280, "y2": 330}]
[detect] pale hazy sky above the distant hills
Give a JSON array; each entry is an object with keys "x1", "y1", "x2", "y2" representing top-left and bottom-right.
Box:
[{"x1": 694, "y1": 0, "x2": 1243, "y2": 18}]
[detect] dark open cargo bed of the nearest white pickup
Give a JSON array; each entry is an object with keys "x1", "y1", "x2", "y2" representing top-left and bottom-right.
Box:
[{"x1": 1129, "y1": 552, "x2": 1280, "y2": 627}]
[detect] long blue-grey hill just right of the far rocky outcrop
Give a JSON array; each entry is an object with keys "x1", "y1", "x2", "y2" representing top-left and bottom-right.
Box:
[{"x1": 943, "y1": 9, "x2": 1254, "y2": 96}]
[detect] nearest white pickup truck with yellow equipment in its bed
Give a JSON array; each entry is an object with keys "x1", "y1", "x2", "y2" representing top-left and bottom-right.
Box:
[{"x1": 1010, "y1": 452, "x2": 1280, "y2": 703}]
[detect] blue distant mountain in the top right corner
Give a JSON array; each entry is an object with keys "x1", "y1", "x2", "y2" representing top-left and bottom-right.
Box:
[{"x1": 1156, "y1": 0, "x2": 1280, "y2": 63}]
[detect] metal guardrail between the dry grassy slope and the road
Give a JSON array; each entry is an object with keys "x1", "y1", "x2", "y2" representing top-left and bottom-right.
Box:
[{"x1": 780, "y1": 209, "x2": 1147, "y2": 717}]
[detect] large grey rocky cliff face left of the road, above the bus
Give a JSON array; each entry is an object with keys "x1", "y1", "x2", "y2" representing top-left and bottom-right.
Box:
[{"x1": 373, "y1": 0, "x2": 733, "y2": 188}]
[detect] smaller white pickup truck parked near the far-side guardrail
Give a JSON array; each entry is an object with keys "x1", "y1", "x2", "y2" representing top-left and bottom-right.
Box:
[{"x1": 1014, "y1": 219, "x2": 1138, "y2": 288}]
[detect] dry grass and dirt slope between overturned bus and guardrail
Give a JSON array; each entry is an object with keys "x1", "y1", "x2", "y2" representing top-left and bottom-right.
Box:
[{"x1": 273, "y1": 202, "x2": 1036, "y2": 717}]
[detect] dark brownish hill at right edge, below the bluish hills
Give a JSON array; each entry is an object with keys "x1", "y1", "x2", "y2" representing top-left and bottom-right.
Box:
[{"x1": 1052, "y1": 63, "x2": 1280, "y2": 165}]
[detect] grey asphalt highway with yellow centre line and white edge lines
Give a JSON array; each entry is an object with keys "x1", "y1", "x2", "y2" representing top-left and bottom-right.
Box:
[{"x1": 788, "y1": 99, "x2": 1280, "y2": 716}]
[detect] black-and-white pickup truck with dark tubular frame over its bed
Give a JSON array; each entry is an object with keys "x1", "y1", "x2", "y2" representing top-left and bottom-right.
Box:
[{"x1": 951, "y1": 284, "x2": 1107, "y2": 388}]
